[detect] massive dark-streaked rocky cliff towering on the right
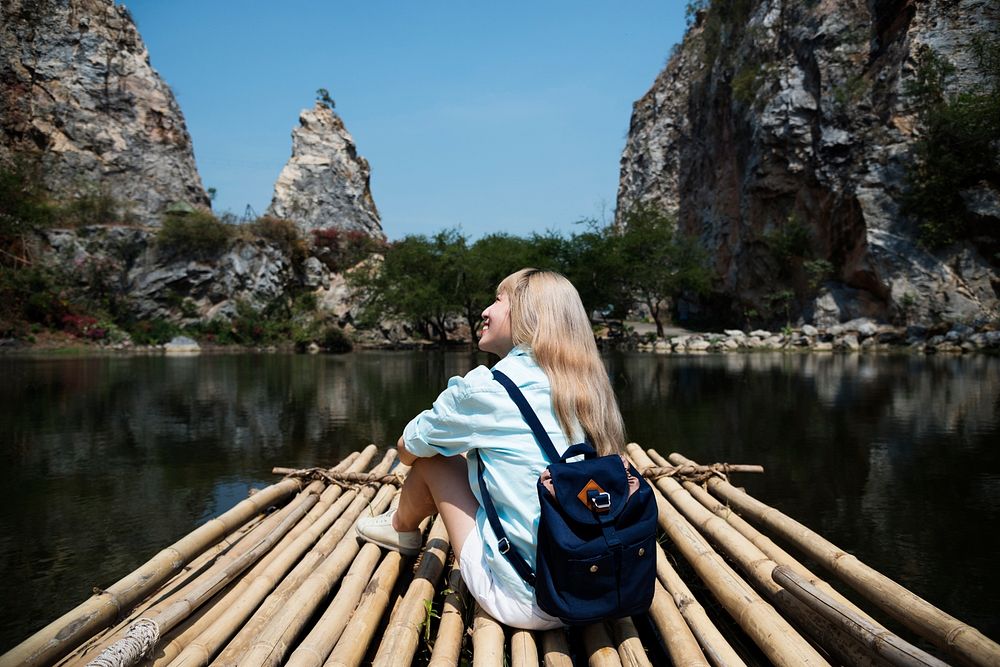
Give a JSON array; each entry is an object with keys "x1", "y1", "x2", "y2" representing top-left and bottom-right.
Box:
[{"x1": 618, "y1": 0, "x2": 1000, "y2": 325}]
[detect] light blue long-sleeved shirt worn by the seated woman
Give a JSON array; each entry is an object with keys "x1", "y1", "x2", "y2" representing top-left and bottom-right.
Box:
[{"x1": 403, "y1": 346, "x2": 583, "y2": 604}]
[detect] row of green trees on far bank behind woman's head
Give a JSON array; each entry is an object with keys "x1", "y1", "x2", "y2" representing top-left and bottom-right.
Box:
[{"x1": 350, "y1": 207, "x2": 710, "y2": 343}]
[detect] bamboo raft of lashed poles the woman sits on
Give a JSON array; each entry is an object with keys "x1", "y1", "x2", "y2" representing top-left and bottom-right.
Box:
[{"x1": 0, "y1": 444, "x2": 1000, "y2": 667}]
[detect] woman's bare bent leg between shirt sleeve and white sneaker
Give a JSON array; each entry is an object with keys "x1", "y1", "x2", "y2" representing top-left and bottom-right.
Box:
[{"x1": 392, "y1": 455, "x2": 479, "y2": 556}]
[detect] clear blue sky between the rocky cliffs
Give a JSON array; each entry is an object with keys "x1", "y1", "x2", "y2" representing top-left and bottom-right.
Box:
[{"x1": 122, "y1": 0, "x2": 684, "y2": 239}]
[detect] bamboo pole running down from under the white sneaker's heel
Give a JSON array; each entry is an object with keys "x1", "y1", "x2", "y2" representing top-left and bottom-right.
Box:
[{"x1": 324, "y1": 551, "x2": 410, "y2": 667}]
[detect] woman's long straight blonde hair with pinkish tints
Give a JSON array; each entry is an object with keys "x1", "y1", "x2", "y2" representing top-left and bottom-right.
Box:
[{"x1": 497, "y1": 269, "x2": 625, "y2": 456}]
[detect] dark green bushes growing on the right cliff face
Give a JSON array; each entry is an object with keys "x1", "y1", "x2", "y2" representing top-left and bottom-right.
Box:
[{"x1": 903, "y1": 36, "x2": 1000, "y2": 253}]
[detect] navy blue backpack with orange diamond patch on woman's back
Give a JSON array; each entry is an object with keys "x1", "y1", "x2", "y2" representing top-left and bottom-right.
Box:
[{"x1": 479, "y1": 370, "x2": 657, "y2": 625}]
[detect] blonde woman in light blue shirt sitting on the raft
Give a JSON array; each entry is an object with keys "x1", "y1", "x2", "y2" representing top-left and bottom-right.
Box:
[{"x1": 357, "y1": 269, "x2": 625, "y2": 630}]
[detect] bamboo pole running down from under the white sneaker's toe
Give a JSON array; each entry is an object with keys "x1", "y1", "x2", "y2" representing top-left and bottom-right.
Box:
[{"x1": 285, "y1": 544, "x2": 382, "y2": 667}]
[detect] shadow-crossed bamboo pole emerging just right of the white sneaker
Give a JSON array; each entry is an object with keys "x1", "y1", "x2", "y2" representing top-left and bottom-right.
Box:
[{"x1": 372, "y1": 515, "x2": 450, "y2": 667}]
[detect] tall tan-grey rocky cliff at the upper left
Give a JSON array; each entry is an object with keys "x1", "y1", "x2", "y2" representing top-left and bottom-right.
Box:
[{"x1": 0, "y1": 0, "x2": 208, "y2": 224}]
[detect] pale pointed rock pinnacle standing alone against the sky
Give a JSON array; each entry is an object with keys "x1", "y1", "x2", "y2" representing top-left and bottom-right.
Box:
[{"x1": 267, "y1": 102, "x2": 385, "y2": 238}]
